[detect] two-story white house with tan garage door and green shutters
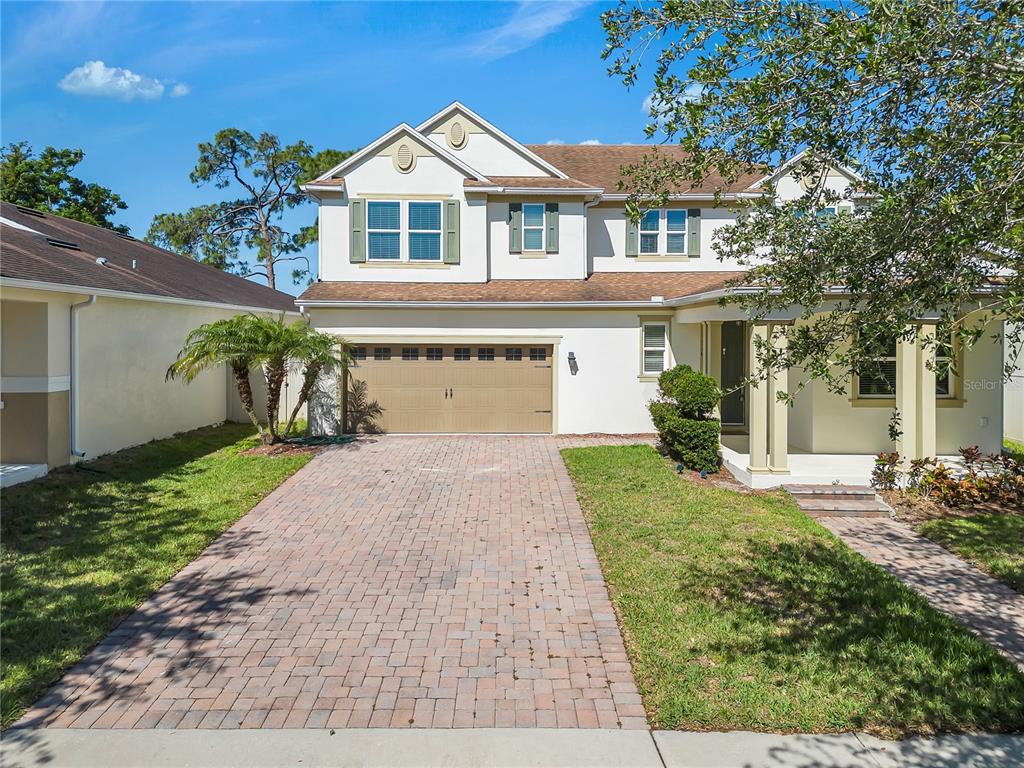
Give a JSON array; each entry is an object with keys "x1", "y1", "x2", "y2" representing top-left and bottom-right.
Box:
[{"x1": 298, "y1": 103, "x2": 1001, "y2": 485}]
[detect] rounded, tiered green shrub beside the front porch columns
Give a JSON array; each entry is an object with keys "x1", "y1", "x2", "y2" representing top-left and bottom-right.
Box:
[{"x1": 648, "y1": 366, "x2": 722, "y2": 472}]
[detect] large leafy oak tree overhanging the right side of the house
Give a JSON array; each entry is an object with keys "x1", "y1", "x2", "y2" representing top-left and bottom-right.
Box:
[{"x1": 602, "y1": 0, "x2": 1024, "y2": 391}]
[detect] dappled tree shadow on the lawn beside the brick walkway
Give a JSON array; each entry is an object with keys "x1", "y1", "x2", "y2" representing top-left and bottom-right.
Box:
[{"x1": 680, "y1": 538, "x2": 1024, "y2": 732}]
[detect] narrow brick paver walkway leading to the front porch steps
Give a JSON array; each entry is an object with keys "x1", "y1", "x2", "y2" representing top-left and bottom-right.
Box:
[{"x1": 818, "y1": 517, "x2": 1024, "y2": 672}]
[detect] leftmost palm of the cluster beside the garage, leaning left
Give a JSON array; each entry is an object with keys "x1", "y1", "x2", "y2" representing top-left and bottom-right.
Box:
[{"x1": 166, "y1": 314, "x2": 268, "y2": 442}]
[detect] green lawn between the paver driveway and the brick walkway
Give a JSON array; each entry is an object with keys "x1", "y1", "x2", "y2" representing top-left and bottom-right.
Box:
[{"x1": 562, "y1": 445, "x2": 1024, "y2": 735}]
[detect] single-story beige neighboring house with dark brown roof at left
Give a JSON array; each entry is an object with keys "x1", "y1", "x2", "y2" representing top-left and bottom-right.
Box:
[{"x1": 0, "y1": 203, "x2": 299, "y2": 484}]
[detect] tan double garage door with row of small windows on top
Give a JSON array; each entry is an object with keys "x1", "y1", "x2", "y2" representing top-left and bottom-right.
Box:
[{"x1": 351, "y1": 343, "x2": 552, "y2": 433}]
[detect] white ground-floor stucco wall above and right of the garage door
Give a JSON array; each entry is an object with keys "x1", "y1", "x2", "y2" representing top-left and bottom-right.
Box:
[{"x1": 311, "y1": 309, "x2": 699, "y2": 434}]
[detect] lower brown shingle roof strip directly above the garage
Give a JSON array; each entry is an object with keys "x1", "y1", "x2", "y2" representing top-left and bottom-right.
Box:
[{"x1": 298, "y1": 271, "x2": 741, "y2": 304}]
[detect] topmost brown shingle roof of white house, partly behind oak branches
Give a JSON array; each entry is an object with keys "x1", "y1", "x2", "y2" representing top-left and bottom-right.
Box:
[{"x1": 527, "y1": 144, "x2": 764, "y2": 195}]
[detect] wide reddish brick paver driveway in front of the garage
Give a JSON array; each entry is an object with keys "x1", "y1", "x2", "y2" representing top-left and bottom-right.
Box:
[{"x1": 24, "y1": 436, "x2": 646, "y2": 728}]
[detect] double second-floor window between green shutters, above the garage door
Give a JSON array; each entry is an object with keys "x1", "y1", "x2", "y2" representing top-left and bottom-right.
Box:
[{"x1": 367, "y1": 200, "x2": 441, "y2": 261}]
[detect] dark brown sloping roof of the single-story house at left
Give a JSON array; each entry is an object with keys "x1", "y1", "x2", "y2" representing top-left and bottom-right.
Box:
[{"x1": 0, "y1": 203, "x2": 296, "y2": 311}]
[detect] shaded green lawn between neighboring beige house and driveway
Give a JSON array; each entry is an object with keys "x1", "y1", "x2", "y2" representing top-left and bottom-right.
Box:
[{"x1": 0, "y1": 424, "x2": 311, "y2": 725}]
